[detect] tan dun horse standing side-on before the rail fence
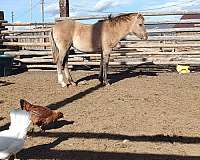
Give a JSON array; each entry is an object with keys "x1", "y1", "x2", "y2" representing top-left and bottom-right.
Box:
[{"x1": 51, "y1": 13, "x2": 148, "y2": 87}]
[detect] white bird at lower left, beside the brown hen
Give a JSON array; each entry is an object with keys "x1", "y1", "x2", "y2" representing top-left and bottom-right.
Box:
[{"x1": 0, "y1": 109, "x2": 31, "y2": 159}]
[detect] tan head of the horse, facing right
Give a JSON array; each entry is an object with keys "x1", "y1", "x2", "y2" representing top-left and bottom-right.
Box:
[{"x1": 131, "y1": 14, "x2": 148, "y2": 40}]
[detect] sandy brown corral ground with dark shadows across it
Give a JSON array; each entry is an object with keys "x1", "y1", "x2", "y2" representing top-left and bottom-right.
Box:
[{"x1": 0, "y1": 71, "x2": 200, "y2": 160}]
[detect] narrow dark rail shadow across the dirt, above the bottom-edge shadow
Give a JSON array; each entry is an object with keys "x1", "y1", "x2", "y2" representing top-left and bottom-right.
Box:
[{"x1": 29, "y1": 132, "x2": 200, "y2": 144}]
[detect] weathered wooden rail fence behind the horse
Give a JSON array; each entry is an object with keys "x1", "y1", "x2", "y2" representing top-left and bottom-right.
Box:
[{"x1": 0, "y1": 12, "x2": 200, "y2": 68}]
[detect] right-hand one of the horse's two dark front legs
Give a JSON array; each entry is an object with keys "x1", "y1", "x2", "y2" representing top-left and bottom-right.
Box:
[{"x1": 103, "y1": 52, "x2": 110, "y2": 85}]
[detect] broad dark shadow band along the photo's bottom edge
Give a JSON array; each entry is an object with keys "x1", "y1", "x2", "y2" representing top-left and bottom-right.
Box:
[{"x1": 17, "y1": 149, "x2": 200, "y2": 160}]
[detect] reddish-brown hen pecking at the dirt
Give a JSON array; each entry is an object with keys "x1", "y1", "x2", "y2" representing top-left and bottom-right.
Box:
[{"x1": 20, "y1": 99, "x2": 63, "y2": 131}]
